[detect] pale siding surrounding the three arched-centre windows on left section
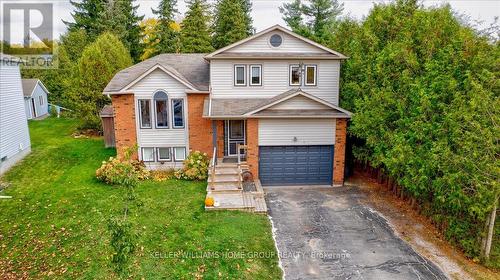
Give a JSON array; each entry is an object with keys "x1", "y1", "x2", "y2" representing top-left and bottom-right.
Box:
[{"x1": 130, "y1": 69, "x2": 189, "y2": 169}]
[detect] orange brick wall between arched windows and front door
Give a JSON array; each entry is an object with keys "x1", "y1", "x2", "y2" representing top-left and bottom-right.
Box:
[{"x1": 187, "y1": 94, "x2": 213, "y2": 157}]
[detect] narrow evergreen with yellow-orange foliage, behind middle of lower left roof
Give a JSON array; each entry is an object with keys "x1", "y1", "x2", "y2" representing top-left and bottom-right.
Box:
[{"x1": 153, "y1": 0, "x2": 180, "y2": 54}]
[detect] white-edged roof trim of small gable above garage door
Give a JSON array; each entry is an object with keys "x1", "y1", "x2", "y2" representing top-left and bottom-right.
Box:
[{"x1": 245, "y1": 88, "x2": 352, "y2": 118}]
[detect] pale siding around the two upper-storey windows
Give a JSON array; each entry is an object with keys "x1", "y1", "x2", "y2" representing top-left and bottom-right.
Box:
[{"x1": 210, "y1": 60, "x2": 340, "y2": 105}]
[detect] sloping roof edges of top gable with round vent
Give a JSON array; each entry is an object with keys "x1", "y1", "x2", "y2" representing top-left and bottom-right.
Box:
[{"x1": 205, "y1": 24, "x2": 347, "y2": 59}]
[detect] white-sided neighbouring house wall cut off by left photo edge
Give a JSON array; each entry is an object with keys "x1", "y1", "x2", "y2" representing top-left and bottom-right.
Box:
[{"x1": 0, "y1": 54, "x2": 31, "y2": 174}]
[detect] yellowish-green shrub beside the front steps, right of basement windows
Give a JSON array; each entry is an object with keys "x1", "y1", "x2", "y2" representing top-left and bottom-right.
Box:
[{"x1": 175, "y1": 151, "x2": 210, "y2": 180}]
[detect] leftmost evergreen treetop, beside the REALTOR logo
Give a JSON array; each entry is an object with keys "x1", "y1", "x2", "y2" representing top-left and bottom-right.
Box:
[{"x1": 63, "y1": 0, "x2": 107, "y2": 40}]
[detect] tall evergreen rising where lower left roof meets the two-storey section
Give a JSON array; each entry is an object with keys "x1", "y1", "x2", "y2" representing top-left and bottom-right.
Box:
[{"x1": 181, "y1": 0, "x2": 214, "y2": 53}]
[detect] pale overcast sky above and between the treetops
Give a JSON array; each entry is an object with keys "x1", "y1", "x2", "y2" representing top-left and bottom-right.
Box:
[{"x1": 0, "y1": 0, "x2": 500, "y2": 42}]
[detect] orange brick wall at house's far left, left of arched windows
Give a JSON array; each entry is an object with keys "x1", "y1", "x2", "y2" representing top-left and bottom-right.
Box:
[{"x1": 111, "y1": 94, "x2": 137, "y2": 158}]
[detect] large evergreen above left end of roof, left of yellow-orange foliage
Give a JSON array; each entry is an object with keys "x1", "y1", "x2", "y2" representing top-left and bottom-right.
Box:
[{"x1": 106, "y1": 0, "x2": 144, "y2": 61}]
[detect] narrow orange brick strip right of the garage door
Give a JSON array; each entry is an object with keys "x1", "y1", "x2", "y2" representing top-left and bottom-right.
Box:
[{"x1": 333, "y1": 119, "x2": 347, "y2": 185}]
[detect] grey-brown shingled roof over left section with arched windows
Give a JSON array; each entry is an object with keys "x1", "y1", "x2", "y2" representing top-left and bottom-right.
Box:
[{"x1": 104, "y1": 54, "x2": 210, "y2": 94}]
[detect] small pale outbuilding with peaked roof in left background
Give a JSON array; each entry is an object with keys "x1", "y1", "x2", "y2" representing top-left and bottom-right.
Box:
[{"x1": 22, "y1": 79, "x2": 49, "y2": 120}]
